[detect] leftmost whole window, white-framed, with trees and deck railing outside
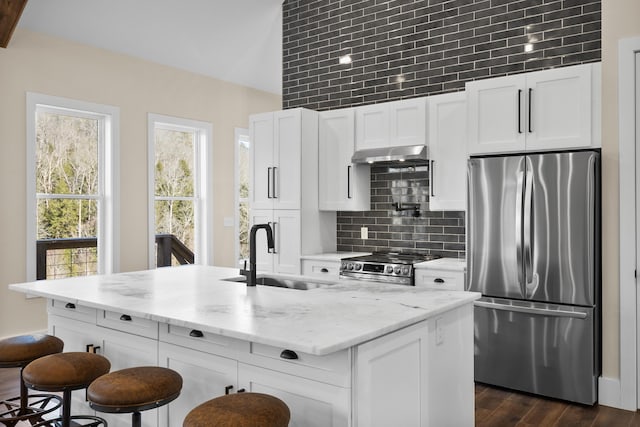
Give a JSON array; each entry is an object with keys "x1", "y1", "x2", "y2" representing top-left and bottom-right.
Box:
[{"x1": 27, "y1": 93, "x2": 119, "y2": 280}]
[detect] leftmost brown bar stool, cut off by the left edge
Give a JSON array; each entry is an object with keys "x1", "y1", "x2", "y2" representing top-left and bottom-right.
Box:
[{"x1": 0, "y1": 334, "x2": 64, "y2": 427}]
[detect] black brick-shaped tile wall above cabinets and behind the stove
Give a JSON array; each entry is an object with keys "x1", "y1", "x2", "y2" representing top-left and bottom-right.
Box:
[{"x1": 282, "y1": 0, "x2": 601, "y2": 257}]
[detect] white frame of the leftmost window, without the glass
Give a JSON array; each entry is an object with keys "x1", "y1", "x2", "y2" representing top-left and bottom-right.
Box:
[{"x1": 26, "y1": 92, "x2": 120, "y2": 281}]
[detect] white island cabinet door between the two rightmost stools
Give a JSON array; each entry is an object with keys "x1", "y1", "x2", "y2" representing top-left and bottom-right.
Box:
[{"x1": 158, "y1": 342, "x2": 238, "y2": 427}]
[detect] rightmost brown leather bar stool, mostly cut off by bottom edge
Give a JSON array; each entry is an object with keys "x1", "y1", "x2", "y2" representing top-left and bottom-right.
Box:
[{"x1": 182, "y1": 393, "x2": 291, "y2": 427}]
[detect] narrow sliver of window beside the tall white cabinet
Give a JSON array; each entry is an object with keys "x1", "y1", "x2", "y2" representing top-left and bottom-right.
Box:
[{"x1": 235, "y1": 129, "x2": 250, "y2": 266}]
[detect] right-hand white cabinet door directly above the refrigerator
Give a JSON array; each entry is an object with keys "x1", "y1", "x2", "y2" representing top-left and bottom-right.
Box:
[{"x1": 526, "y1": 64, "x2": 592, "y2": 151}]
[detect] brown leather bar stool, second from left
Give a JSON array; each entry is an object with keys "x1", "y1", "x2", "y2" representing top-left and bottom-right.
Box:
[{"x1": 23, "y1": 352, "x2": 111, "y2": 427}]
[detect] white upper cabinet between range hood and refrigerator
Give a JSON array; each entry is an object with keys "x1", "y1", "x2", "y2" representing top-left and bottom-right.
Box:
[{"x1": 428, "y1": 92, "x2": 467, "y2": 211}]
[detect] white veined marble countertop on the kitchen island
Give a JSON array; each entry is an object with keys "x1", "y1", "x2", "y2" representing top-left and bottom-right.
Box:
[{"x1": 9, "y1": 265, "x2": 480, "y2": 355}]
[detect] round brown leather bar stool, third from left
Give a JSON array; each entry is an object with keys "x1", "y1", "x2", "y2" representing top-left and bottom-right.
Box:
[{"x1": 87, "y1": 366, "x2": 182, "y2": 427}]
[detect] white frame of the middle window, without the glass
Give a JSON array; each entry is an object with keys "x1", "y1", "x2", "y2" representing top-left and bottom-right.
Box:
[{"x1": 147, "y1": 113, "x2": 213, "y2": 269}]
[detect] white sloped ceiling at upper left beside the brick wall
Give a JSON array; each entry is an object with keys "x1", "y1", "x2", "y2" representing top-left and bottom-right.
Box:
[{"x1": 5, "y1": 0, "x2": 283, "y2": 94}]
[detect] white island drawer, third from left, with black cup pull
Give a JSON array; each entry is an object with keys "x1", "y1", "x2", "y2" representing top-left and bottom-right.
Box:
[{"x1": 160, "y1": 323, "x2": 249, "y2": 358}]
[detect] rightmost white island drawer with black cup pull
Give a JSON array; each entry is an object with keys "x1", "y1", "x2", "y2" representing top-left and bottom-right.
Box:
[{"x1": 248, "y1": 343, "x2": 351, "y2": 387}]
